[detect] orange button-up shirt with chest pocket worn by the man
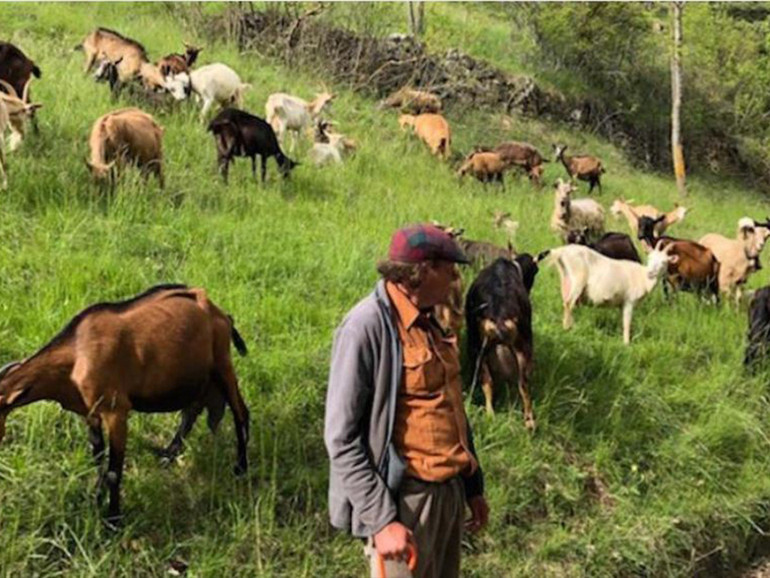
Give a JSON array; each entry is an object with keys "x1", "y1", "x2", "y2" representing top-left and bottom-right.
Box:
[{"x1": 385, "y1": 282, "x2": 478, "y2": 482}]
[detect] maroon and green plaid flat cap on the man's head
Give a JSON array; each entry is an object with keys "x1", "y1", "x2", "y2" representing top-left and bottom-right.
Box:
[{"x1": 388, "y1": 225, "x2": 470, "y2": 264}]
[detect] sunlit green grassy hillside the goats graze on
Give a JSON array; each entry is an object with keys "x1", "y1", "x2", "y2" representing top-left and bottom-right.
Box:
[{"x1": 0, "y1": 4, "x2": 770, "y2": 578}]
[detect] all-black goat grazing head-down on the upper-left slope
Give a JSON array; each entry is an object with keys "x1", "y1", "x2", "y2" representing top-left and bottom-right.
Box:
[{"x1": 208, "y1": 108, "x2": 299, "y2": 183}]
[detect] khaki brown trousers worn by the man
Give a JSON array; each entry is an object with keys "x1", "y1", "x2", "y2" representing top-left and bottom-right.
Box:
[{"x1": 365, "y1": 476, "x2": 465, "y2": 578}]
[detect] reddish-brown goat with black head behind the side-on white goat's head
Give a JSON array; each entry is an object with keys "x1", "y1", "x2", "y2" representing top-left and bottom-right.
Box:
[{"x1": 638, "y1": 215, "x2": 720, "y2": 303}]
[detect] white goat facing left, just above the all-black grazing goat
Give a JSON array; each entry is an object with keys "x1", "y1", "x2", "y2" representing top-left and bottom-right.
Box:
[{"x1": 165, "y1": 62, "x2": 251, "y2": 121}]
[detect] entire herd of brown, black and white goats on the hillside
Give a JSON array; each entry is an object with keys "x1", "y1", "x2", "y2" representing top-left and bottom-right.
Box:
[{"x1": 0, "y1": 28, "x2": 770, "y2": 522}]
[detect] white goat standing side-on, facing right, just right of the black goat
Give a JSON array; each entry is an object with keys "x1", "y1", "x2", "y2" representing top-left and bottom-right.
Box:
[{"x1": 538, "y1": 245, "x2": 677, "y2": 345}]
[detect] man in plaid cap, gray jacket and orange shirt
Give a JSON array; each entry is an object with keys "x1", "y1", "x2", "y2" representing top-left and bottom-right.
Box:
[{"x1": 324, "y1": 225, "x2": 489, "y2": 578}]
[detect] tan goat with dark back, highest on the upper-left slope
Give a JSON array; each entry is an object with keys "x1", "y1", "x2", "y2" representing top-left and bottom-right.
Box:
[{"x1": 75, "y1": 28, "x2": 164, "y2": 91}]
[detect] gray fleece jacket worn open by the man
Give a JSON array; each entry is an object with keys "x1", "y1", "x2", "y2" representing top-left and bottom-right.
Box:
[{"x1": 324, "y1": 281, "x2": 484, "y2": 538}]
